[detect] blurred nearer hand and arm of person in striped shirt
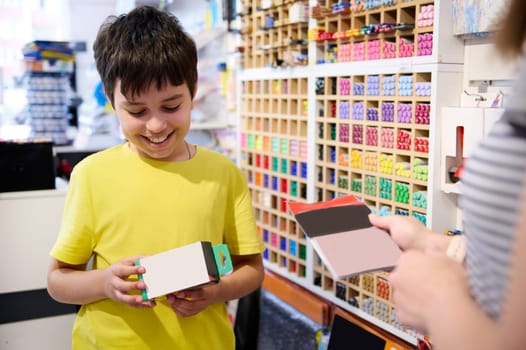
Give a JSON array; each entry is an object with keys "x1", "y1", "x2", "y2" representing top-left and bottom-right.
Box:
[{"x1": 389, "y1": 179, "x2": 526, "y2": 350}]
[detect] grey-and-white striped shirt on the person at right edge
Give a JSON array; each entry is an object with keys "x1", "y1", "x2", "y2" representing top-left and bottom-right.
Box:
[{"x1": 460, "y1": 56, "x2": 526, "y2": 319}]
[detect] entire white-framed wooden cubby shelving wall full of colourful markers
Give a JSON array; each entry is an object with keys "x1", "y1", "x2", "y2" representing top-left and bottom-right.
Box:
[{"x1": 239, "y1": 0, "x2": 463, "y2": 344}]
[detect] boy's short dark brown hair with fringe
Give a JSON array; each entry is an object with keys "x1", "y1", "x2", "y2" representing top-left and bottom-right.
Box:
[{"x1": 93, "y1": 6, "x2": 197, "y2": 105}]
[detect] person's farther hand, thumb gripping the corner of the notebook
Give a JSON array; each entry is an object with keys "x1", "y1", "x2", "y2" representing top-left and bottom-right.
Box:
[{"x1": 369, "y1": 214, "x2": 451, "y2": 252}]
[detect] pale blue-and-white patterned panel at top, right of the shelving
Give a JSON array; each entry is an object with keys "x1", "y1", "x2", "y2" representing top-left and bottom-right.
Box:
[{"x1": 451, "y1": 0, "x2": 507, "y2": 35}]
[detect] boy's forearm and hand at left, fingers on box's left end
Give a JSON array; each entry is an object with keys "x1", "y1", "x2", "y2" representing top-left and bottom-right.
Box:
[{"x1": 47, "y1": 257, "x2": 153, "y2": 307}]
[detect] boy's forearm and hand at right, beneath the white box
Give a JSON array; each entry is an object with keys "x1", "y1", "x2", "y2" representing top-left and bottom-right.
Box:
[{"x1": 167, "y1": 254, "x2": 264, "y2": 317}]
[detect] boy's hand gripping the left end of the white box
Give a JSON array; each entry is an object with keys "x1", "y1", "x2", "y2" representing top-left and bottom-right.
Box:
[{"x1": 104, "y1": 256, "x2": 155, "y2": 308}]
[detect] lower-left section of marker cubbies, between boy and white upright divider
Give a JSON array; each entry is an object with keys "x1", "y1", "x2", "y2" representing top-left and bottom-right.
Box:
[{"x1": 241, "y1": 78, "x2": 308, "y2": 277}]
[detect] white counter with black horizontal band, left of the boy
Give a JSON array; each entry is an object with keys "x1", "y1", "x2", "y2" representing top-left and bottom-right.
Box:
[{"x1": 0, "y1": 189, "x2": 77, "y2": 350}]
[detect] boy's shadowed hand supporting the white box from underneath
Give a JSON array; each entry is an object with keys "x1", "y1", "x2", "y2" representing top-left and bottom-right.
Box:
[{"x1": 166, "y1": 282, "x2": 221, "y2": 317}]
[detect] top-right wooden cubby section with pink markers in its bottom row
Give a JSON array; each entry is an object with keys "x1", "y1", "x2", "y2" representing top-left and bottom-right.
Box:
[{"x1": 313, "y1": 0, "x2": 433, "y2": 62}]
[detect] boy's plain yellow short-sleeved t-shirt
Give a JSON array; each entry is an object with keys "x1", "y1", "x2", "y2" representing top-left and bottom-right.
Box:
[{"x1": 51, "y1": 144, "x2": 264, "y2": 350}]
